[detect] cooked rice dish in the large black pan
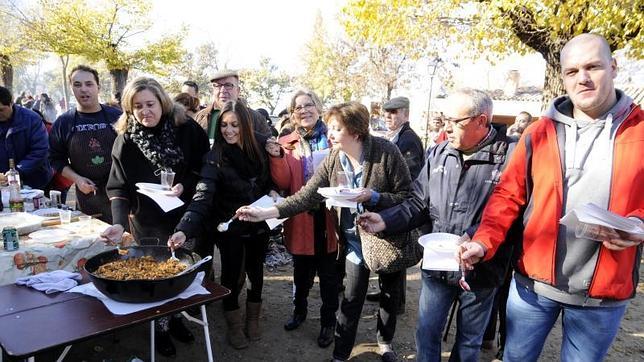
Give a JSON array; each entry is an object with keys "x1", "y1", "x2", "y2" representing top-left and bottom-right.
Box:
[{"x1": 96, "y1": 256, "x2": 187, "y2": 280}]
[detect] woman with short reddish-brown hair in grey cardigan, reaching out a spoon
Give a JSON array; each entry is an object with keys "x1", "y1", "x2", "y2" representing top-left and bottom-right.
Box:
[{"x1": 237, "y1": 102, "x2": 411, "y2": 361}]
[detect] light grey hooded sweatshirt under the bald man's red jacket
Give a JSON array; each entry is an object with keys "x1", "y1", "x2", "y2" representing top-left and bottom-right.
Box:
[{"x1": 530, "y1": 90, "x2": 633, "y2": 306}]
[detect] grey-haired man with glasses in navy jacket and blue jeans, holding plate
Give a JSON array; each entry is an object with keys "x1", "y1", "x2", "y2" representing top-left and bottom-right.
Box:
[{"x1": 358, "y1": 88, "x2": 516, "y2": 361}]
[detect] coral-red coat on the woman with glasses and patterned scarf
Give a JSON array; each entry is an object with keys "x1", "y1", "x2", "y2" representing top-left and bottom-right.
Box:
[{"x1": 269, "y1": 132, "x2": 338, "y2": 255}]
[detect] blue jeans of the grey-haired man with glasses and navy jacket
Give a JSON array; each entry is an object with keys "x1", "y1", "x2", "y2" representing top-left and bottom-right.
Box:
[{"x1": 416, "y1": 270, "x2": 496, "y2": 362}]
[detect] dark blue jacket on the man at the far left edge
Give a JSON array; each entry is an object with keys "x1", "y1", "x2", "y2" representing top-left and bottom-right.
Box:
[{"x1": 0, "y1": 105, "x2": 53, "y2": 189}]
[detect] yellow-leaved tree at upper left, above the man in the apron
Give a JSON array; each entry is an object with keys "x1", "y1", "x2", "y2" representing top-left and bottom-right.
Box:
[{"x1": 6, "y1": 0, "x2": 184, "y2": 102}]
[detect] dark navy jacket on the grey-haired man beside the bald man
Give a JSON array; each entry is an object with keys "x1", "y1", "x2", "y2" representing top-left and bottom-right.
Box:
[{"x1": 380, "y1": 125, "x2": 520, "y2": 287}]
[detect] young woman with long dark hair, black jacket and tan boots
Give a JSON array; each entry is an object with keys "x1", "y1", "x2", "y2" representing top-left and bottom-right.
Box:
[{"x1": 168, "y1": 101, "x2": 277, "y2": 349}]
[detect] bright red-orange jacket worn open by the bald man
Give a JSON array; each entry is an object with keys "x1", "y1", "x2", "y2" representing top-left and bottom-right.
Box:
[{"x1": 472, "y1": 105, "x2": 644, "y2": 300}]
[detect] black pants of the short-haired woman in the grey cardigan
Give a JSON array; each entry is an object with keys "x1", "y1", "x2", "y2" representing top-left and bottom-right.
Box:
[{"x1": 333, "y1": 260, "x2": 401, "y2": 360}]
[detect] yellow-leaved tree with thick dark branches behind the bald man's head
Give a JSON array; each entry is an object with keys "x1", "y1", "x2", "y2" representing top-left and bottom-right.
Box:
[{"x1": 460, "y1": 0, "x2": 644, "y2": 106}]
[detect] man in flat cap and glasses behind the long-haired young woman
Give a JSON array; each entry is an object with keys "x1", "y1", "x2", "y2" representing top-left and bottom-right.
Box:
[{"x1": 195, "y1": 70, "x2": 271, "y2": 144}]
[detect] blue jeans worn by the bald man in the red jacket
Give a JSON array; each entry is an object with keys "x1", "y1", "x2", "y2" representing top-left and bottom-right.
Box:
[{"x1": 503, "y1": 279, "x2": 626, "y2": 362}]
